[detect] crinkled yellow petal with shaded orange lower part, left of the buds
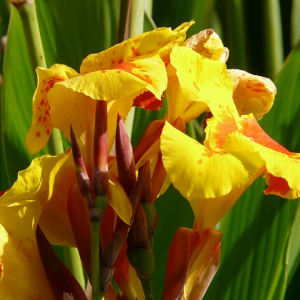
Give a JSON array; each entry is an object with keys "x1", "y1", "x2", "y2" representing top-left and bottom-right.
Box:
[{"x1": 1, "y1": 153, "x2": 77, "y2": 246}]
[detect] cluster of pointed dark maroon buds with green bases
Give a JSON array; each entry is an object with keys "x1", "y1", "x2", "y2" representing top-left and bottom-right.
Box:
[{"x1": 68, "y1": 101, "x2": 158, "y2": 295}]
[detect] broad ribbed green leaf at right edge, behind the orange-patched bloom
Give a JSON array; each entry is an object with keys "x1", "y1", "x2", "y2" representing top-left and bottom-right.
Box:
[{"x1": 205, "y1": 37, "x2": 300, "y2": 300}]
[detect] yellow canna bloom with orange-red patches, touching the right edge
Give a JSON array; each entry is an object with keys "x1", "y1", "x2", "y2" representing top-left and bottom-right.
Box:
[{"x1": 161, "y1": 112, "x2": 300, "y2": 232}]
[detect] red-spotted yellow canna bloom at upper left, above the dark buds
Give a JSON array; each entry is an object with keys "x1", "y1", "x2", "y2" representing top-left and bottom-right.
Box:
[{"x1": 26, "y1": 22, "x2": 193, "y2": 153}]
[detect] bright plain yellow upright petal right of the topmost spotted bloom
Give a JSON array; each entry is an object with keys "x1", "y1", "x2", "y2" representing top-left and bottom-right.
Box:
[{"x1": 167, "y1": 47, "x2": 237, "y2": 122}]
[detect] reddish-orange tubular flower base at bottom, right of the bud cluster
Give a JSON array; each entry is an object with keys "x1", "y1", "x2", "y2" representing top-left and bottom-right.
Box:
[{"x1": 162, "y1": 227, "x2": 222, "y2": 300}]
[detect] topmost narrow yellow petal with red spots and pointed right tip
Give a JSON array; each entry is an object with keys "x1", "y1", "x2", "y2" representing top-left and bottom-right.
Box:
[{"x1": 80, "y1": 21, "x2": 194, "y2": 74}]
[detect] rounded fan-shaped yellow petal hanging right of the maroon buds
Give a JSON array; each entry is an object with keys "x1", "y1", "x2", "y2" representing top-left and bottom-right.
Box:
[{"x1": 161, "y1": 122, "x2": 262, "y2": 201}]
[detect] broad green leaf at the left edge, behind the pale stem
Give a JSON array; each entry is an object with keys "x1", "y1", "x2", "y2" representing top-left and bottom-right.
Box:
[{"x1": 1, "y1": 8, "x2": 46, "y2": 190}]
